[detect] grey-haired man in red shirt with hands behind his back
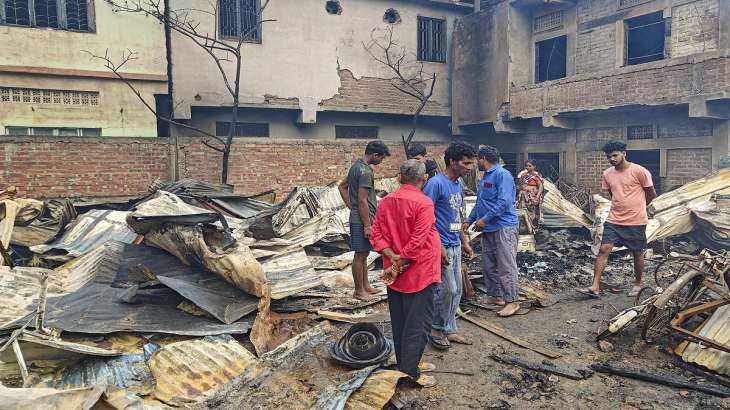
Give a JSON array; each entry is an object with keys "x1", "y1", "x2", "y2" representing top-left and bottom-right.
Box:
[{"x1": 370, "y1": 159, "x2": 441, "y2": 387}]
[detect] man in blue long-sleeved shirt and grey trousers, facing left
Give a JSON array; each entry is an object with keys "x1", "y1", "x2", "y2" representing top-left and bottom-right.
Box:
[{"x1": 467, "y1": 146, "x2": 520, "y2": 317}]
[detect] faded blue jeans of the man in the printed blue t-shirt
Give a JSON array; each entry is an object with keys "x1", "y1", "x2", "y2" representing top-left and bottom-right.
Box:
[{"x1": 431, "y1": 245, "x2": 464, "y2": 335}]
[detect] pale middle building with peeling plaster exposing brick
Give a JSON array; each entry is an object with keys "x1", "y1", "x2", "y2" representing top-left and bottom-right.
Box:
[{"x1": 172, "y1": 0, "x2": 473, "y2": 142}]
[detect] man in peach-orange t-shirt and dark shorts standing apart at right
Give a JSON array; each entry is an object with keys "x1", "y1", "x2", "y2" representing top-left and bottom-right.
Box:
[{"x1": 577, "y1": 141, "x2": 656, "y2": 297}]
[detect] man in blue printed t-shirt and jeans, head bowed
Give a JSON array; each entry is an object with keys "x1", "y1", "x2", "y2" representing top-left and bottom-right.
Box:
[{"x1": 423, "y1": 142, "x2": 476, "y2": 349}]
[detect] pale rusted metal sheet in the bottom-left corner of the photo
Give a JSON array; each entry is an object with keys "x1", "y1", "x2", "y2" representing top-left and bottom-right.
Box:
[{"x1": 0, "y1": 385, "x2": 106, "y2": 410}]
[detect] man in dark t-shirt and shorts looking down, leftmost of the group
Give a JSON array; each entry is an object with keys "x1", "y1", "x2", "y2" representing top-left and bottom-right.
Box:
[{"x1": 339, "y1": 140, "x2": 390, "y2": 300}]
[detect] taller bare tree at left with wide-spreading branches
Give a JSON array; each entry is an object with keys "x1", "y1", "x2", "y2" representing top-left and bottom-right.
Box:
[{"x1": 86, "y1": 0, "x2": 275, "y2": 183}]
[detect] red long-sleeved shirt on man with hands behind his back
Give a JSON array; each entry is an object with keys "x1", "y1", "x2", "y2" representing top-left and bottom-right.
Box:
[{"x1": 370, "y1": 184, "x2": 441, "y2": 293}]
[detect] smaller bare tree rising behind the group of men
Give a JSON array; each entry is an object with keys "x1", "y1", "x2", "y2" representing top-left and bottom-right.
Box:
[{"x1": 363, "y1": 24, "x2": 436, "y2": 156}]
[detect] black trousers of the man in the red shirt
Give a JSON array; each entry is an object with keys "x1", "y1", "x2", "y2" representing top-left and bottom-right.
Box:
[{"x1": 388, "y1": 283, "x2": 436, "y2": 380}]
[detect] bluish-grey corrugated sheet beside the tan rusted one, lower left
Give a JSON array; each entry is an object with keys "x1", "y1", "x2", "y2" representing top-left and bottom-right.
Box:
[{"x1": 33, "y1": 344, "x2": 158, "y2": 394}]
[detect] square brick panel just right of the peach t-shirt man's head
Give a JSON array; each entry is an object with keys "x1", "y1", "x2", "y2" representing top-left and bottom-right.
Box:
[{"x1": 663, "y1": 148, "x2": 712, "y2": 192}]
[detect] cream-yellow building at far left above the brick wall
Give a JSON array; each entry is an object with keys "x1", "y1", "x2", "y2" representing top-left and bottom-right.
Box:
[{"x1": 0, "y1": 0, "x2": 167, "y2": 137}]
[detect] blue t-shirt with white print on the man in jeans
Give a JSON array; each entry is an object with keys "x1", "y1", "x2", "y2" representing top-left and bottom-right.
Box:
[{"x1": 423, "y1": 173, "x2": 464, "y2": 246}]
